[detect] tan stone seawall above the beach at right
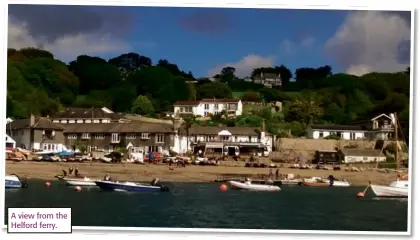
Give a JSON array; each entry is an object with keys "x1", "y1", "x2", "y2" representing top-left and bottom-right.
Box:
[{"x1": 270, "y1": 138, "x2": 400, "y2": 162}]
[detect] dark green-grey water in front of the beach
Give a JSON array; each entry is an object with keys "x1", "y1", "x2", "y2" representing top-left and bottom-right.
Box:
[{"x1": 5, "y1": 180, "x2": 408, "y2": 231}]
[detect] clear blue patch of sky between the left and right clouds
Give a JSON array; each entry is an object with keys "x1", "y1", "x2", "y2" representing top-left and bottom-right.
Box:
[{"x1": 104, "y1": 7, "x2": 348, "y2": 76}]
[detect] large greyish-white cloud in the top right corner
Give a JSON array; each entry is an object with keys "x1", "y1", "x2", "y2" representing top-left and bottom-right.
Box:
[{"x1": 325, "y1": 11, "x2": 410, "y2": 75}]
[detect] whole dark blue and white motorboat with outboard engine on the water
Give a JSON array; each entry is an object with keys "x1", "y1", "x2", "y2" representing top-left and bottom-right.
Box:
[{"x1": 94, "y1": 178, "x2": 169, "y2": 192}]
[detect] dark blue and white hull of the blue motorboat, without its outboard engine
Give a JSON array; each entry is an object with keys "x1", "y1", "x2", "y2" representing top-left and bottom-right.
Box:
[{"x1": 94, "y1": 181, "x2": 167, "y2": 192}]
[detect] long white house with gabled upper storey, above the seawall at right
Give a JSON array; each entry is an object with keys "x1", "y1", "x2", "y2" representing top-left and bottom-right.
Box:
[{"x1": 306, "y1": 114, "x2": 394, "y2": 140}]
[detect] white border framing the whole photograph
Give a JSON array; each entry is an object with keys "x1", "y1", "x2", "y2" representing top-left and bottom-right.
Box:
[{"x1": 0, "y1": 0, "x2": 420, "y2": 239}]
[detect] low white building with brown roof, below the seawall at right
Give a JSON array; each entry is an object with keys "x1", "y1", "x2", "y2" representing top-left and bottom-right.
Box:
[{"x1": 339, "y1": 148, "x2": 386, "y2": 163}]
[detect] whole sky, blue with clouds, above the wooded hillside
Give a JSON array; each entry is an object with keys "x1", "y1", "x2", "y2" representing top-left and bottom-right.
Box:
[{"x1": 8, "y1": 5, "x2": 411, "y2": 77}]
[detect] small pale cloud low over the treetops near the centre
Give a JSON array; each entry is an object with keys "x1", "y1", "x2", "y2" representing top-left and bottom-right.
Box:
[{"x1": 208, "y1": 55, "x2": 274, "y2": 77}]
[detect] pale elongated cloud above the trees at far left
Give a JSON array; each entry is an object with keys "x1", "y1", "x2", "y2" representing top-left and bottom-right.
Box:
[{"x1": 8, "y1": 18, "x2": 131, "y2": 61}]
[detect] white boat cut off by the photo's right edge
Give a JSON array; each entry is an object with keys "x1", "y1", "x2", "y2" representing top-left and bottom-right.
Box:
[{"x1": 370, "y1": 179, "x2": 409, "y2": 198}]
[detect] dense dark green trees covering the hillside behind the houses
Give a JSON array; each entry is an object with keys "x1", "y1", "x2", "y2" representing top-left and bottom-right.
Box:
[{"x1": 7, "y1": 48, "x2": 410, "y2": 141}]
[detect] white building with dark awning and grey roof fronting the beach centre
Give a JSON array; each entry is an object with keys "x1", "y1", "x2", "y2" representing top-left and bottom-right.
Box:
[{"x1": 172, "y1": 125, "x2": 274, "y2": 155}]
